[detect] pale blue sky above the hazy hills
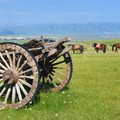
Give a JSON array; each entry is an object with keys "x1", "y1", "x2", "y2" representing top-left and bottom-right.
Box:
[{"x1": 0, "y1": 0, "x2": 120, "y2": 26}]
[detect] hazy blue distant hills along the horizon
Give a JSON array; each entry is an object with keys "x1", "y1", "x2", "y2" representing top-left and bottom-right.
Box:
[{"x1": 0, "y1": 23, "x2": 120, "y2": 39}]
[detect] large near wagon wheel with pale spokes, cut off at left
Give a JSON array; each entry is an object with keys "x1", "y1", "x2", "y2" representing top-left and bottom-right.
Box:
[{"x1": 0, "y1": 43, "x2": 39, "y2": 109}]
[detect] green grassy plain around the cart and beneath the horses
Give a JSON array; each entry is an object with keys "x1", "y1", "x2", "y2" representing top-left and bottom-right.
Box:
[{"x1": 0, "y1": 39, "x2": 120, "y2": 120}]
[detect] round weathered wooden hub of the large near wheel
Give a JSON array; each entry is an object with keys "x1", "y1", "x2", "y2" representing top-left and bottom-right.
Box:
[{"x1": 3, "y1": 70, "x2": 18, "y2": 84}]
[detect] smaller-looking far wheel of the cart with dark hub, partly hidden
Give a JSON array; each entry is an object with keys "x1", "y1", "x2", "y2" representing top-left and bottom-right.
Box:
[{"x1": 41, "y1": 52, "x2": 72, "y2": 91}]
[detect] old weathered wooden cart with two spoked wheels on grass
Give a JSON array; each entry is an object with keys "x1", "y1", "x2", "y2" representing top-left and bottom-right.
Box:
[{"x1": 0, "y1": 38, "x2": 72, "y2": 109}]
